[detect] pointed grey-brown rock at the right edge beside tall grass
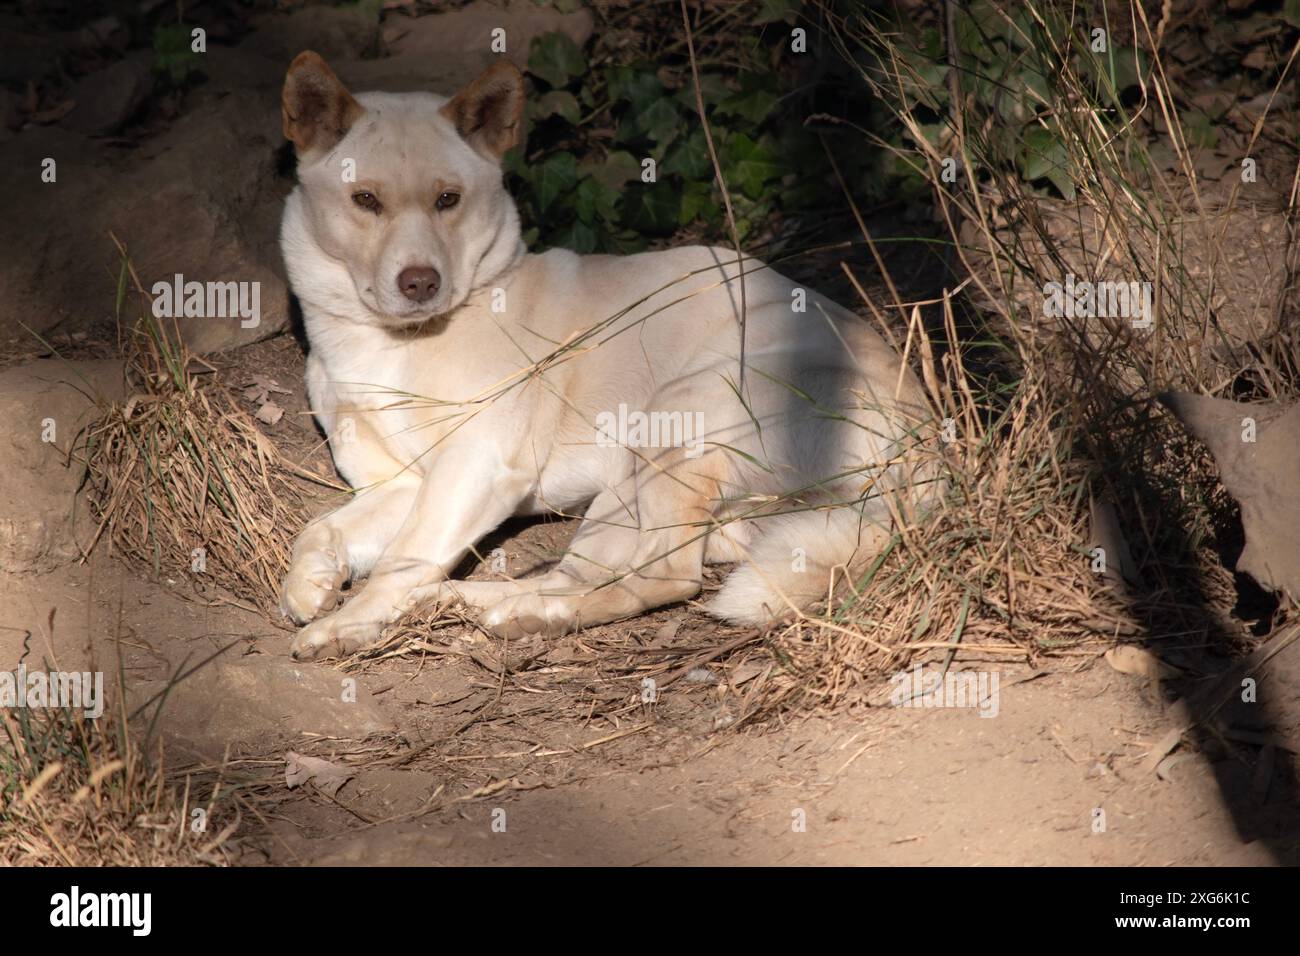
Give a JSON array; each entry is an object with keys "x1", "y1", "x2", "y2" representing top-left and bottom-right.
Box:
[{"x1": 1160, "y1": 392, "x2": 1300, "y2": 601}]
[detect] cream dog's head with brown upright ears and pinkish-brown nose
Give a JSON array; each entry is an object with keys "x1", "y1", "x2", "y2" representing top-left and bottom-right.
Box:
[{"x1": 281, "y1": 52, "x2": 524, "y2": 328}]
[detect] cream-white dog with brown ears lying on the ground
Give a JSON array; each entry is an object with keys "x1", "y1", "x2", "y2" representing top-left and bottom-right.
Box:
[{"x1": 281, "y1": 52, "x2": 939, "y2": 658}]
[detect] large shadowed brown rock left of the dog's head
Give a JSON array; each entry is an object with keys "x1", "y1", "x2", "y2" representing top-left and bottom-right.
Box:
[{"x1": 0, "y1": 91, "x2": 290, "y2": 352}]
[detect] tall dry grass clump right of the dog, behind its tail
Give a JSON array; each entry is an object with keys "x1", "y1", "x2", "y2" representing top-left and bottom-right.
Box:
[{"x1": 733, "y1": 0, "x2": 1296, "y2": 709}]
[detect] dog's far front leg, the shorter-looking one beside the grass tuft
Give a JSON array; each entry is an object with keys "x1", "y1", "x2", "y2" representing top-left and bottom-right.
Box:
[{"x1": 280, "y1": 475, "x2": 420, "y2": 624}]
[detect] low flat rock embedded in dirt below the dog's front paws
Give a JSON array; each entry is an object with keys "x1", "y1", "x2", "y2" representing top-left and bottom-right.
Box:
[{"x1": 130, "y1": 648, "x2": 394, "y2": 758}]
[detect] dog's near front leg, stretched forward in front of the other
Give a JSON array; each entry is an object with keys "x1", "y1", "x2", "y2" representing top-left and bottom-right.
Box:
[{"x1": 291, "y1": 445, "x2": 536, "y2": 661}]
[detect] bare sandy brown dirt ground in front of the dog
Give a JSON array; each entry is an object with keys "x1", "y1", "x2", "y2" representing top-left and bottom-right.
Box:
[{"x1": 0, "y1": 336, "x2": 1300, "y2": 866}]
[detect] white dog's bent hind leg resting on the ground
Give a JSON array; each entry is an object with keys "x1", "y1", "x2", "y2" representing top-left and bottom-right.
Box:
[{"x1": 482, "y1": 449, "x2": 728, "y2": 636}]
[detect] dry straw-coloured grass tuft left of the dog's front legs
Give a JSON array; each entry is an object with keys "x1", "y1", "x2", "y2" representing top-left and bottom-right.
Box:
[{"x1": 82, "y1": 251, "x2": 338, "y2": 614}]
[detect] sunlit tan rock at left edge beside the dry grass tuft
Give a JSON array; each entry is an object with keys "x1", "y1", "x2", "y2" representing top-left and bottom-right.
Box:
[{"x1": 0, "y1": 359, "x2": 122, "y2": 572}]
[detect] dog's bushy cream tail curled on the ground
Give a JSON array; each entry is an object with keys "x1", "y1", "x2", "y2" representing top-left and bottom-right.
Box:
[{"x1": 707, "y1": 505, "x2": 893, "y2": 624}]
